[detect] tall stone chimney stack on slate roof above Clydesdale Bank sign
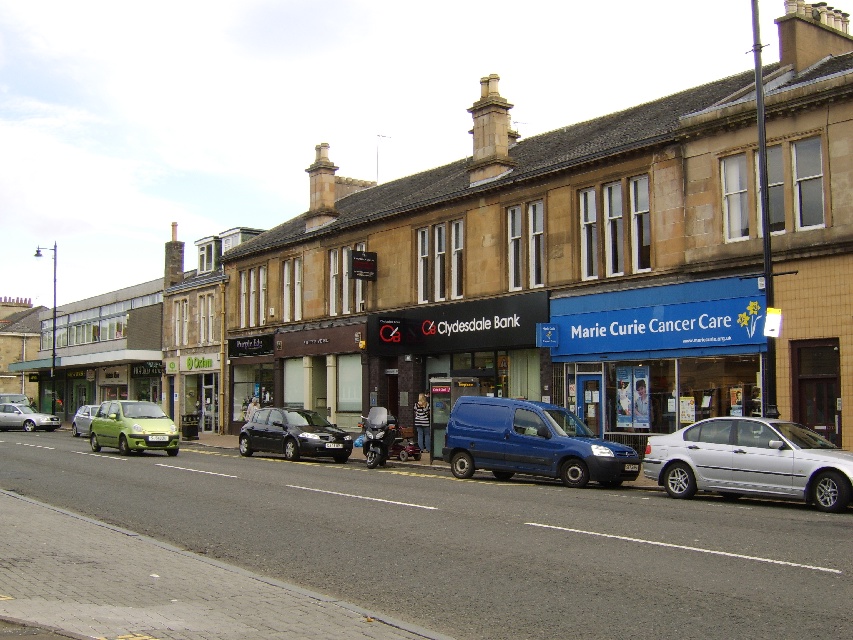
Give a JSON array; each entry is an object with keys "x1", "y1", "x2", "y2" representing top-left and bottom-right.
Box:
[{"x1": 468, "y1": 73, "x2": 518, "y2": 185}]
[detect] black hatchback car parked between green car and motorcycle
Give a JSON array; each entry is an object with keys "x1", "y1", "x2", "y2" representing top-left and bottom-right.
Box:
[{"x1": 240, "y1": 407, "x2": 352, "y2": 462}]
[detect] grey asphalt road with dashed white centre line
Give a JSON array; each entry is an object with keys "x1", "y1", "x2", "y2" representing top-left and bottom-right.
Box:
[{"x1": 0, "y1": 432, "x2": 853, "y2": 640}]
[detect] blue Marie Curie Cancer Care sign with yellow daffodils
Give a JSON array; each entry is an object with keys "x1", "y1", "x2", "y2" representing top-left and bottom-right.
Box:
[{"x1": 558, "y1": 297, "x2": 766, "y2": 354}]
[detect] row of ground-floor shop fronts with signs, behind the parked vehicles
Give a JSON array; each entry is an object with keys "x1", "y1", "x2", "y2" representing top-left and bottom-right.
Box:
[{"x1": 31, "y1": 277, "x2": 841, "y2": 456}]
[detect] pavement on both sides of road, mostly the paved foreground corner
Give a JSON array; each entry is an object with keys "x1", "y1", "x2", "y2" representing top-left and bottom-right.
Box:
[{"x1": 0, "y1": 424, "x2": 657, "y2": 640}]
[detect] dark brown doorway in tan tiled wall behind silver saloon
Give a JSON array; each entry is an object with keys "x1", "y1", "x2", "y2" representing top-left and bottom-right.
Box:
[{"x1": 791, "y1": 340, "x2": 841, "y2": 446}]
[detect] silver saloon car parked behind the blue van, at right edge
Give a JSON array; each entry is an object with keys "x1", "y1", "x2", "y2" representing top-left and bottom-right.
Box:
[{"x1": 643, "y1": 417, "x2": 853, "y2": 512}]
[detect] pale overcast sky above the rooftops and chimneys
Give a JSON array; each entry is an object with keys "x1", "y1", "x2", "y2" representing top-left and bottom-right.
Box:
[{"x1": 0, "y1": 0, "x2": 784, "y2": 307}]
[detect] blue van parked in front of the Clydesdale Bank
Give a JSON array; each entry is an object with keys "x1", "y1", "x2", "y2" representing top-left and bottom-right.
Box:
[{"x1": 441, "y1": 396, "x2": 640, "y2": 488}]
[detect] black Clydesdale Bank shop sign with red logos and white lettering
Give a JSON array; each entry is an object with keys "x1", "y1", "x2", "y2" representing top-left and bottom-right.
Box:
[{"x1": 367, "y1": 291, "x2": 549, "y2": 356}]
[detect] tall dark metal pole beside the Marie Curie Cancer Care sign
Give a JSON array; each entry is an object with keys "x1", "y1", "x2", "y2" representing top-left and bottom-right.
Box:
[{"x1": 752, "y1": 0, "x2": 779, "y2": 418}]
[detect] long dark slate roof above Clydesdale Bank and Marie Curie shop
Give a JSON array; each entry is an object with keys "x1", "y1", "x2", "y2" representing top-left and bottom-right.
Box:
[{"x1": 223, "y1": 55, "x2": 853, "y2": 262}]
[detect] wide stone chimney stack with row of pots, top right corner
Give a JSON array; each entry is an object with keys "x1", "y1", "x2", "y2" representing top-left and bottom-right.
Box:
[{"x1": 776, "y1": 0, "x2": 853, "y2": 72}]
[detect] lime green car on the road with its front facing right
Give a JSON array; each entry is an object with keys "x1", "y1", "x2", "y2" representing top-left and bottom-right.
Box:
[{"x1": 89, "y1": 400, "x2": 181, "y2": 456}]
